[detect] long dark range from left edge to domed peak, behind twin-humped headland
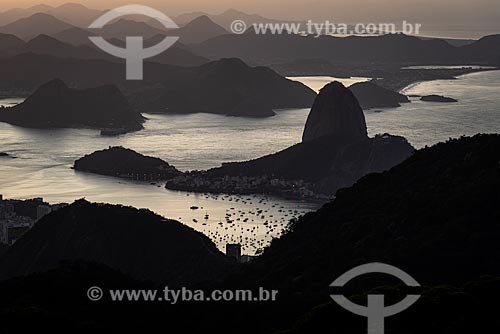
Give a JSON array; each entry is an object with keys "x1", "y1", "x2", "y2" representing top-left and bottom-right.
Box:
[{"x1": 0, "y1": 53, "x2": 316, "y2": 117}]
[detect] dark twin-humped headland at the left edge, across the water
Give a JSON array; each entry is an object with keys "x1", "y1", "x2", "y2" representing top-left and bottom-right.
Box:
[{"x1": 0, "y1": 79, "x2": 144, "y2": 131}]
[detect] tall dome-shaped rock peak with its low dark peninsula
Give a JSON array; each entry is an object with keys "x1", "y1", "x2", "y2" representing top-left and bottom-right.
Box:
[{"x1": 167, "y1": 82, "x2": 414, "y2": 196}]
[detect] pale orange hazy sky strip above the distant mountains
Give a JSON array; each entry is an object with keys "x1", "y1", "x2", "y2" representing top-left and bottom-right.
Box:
[{"x1": 0, "y1": 0, "x2": 500, "y2": 28}]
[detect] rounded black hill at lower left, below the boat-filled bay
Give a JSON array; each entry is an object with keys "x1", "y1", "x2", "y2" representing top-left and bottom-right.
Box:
[{"x1": 0, "y1": 200, "x2": 228, "y2": 286}]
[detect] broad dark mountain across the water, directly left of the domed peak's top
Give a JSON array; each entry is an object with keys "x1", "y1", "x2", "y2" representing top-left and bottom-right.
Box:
[{"x1": 131, "y1": 59, "x2": 315, "y2": 117}]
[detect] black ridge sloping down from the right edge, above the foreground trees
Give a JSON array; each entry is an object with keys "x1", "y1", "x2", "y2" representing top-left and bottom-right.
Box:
[{"x1": 248, "y1": 135, "x2": 500, "y2": 293}]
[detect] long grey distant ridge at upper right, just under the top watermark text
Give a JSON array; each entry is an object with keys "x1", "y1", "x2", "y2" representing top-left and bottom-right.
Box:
[{"x1": 191, "y1": 32, "x2": 500, "y2": 64}]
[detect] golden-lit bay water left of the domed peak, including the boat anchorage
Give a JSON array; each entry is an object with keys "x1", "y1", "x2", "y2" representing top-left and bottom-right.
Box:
[{"x1": 0, "y1": 109, "x2": 319, "y2": 253}]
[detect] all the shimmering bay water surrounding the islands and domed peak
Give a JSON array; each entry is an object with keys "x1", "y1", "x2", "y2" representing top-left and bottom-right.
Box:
[{"x1": 0, "y1": 71, "x2": 500, "y2": 253}]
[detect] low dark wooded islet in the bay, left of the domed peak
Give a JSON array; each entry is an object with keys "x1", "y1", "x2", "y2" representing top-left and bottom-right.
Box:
[{"x1": 74, "y1": 146, "x2": 182, "y2": 181}]
